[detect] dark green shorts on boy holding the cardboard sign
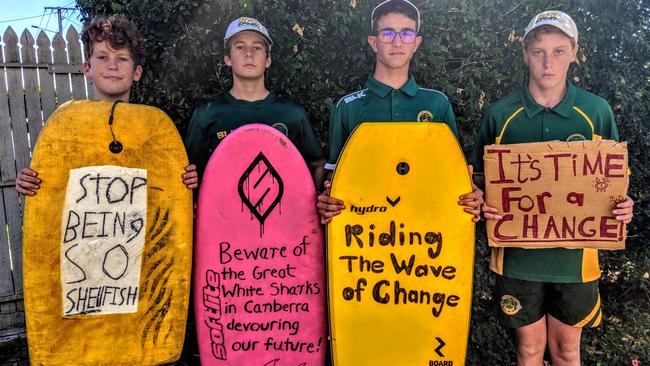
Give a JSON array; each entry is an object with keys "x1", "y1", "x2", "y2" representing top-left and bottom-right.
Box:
[{"x1": 494, "y1": 275, "x2": 602, "y2": 328}]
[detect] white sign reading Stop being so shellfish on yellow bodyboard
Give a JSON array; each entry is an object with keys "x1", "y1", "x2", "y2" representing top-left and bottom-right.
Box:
[{"x1": 61, "y1": 165, "x2": 147, "y2": 316}]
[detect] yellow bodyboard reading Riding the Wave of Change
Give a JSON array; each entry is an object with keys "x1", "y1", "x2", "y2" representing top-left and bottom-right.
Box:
[{"x1": 327, "y1": 122, "x2": 474, "y2": 366}]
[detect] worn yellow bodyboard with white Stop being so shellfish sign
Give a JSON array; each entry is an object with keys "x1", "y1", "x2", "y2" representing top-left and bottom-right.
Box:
[{"x1": 23, "y1": 101, "x2": 192, "y2": 365}]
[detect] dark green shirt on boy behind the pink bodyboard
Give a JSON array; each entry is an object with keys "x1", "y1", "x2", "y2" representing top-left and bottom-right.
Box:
[{"x1": 184, "y1": 93, "x2": 323, "y2": 177}]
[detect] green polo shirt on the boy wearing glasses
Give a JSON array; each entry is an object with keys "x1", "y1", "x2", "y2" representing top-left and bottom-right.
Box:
[{"x1": 325, "y1": 75, "x2": 458, "y2": 170}]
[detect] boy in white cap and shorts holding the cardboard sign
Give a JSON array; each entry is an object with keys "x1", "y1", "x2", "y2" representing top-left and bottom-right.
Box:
[{"x1": 470, "y1": 10, "x2": 633, "y2": 366}]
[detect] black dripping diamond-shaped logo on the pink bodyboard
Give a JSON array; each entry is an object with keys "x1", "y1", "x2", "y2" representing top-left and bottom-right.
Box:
[{"x1": 238, "y1": 152, "x2": 284, "y2": 236}]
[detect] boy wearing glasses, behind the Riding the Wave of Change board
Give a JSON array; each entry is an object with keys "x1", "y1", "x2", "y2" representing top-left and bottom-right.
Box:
[{"x1": 318, "y1": 0, "x2": 483, "y2": 224}]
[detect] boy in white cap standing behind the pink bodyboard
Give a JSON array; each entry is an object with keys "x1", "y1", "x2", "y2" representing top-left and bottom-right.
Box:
[{"x1": 185, "y1": 17, "x2": 324, "y2": 186}]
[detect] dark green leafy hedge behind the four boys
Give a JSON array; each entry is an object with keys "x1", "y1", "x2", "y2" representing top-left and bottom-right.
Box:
[{"x1": 77, "y1": 0, "x2": 650, "y2": 365}]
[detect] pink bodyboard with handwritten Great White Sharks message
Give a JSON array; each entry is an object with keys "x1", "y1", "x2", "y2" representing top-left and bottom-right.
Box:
[{"x1": 193, "y1": 124, "x2": 326, "y2": 366}]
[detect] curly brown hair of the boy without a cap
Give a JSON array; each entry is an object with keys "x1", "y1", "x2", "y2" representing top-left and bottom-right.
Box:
[{"x1": 81, "y1": 15, "x2": 144, "y2": 66}]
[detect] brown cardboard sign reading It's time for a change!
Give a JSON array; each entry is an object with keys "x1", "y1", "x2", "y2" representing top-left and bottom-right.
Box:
[{"x1": 483, "y1": 141, "x2": 629, "y2": 249}]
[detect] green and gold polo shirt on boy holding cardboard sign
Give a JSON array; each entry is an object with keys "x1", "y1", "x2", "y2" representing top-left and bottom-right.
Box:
[{"x1": 470, "y1": 82, "x2": 619, "y2": 283}]
